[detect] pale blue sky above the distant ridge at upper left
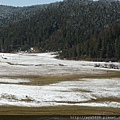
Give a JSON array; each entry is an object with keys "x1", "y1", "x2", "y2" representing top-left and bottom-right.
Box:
[{"x1": 0, "y1": 0, "x2": 63, "y2": 6}]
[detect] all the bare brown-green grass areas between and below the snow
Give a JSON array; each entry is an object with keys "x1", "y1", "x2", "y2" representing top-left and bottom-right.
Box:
[{"x1": 0, "y1": 71, "x2": 120, "y2": 115}]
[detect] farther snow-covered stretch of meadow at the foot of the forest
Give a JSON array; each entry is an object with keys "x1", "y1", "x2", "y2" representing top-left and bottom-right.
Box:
[{"x1": 0, "y1": 53, "x2": 120, "y2": 76}]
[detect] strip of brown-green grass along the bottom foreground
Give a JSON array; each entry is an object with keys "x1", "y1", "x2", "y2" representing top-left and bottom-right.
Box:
[{"x1": 0, "y1": 106, "x2": 120, "y2": 115}]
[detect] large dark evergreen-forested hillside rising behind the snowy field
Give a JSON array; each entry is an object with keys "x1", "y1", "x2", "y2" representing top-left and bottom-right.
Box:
[{"x1": 0, "y1": 0, "x2": 120, "y2": 61}]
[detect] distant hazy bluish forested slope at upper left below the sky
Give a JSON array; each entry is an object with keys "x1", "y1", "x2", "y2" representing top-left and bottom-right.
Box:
[{"x1": 0, "y1": 5, "x2": 47, "y2": 28}]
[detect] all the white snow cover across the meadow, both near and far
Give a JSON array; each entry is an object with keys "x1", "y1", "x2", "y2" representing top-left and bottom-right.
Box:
[{"x1": 0, "y1": 53, "x2": 120, "y2": 108}]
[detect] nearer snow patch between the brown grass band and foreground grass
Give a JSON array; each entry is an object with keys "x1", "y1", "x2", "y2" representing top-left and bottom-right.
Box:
[{"x1": 0, "y1": 79, "x2": 120, "y2": 108}]
